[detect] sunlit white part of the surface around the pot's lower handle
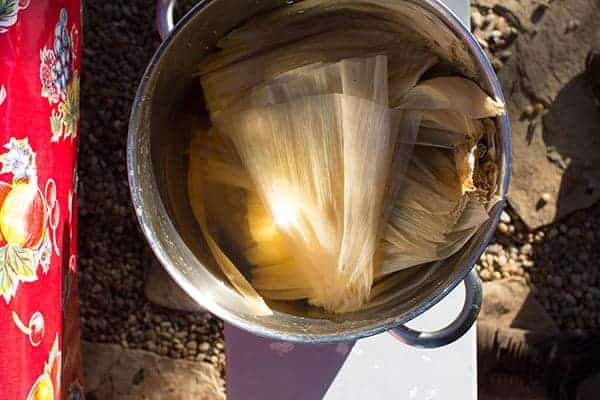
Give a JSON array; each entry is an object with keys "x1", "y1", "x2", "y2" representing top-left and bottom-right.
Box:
[{"x1": 324, "y1": 286, "x2": 477, "y2": 400}]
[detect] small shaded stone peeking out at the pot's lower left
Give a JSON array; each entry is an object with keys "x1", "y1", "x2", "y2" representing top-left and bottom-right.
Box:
[{"x1": 144, "y1": 252, "x2": 206, "y2": 312}]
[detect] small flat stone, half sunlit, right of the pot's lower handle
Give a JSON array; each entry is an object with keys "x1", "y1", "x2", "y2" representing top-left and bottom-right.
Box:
[{"x1": 478, "y1": 278, "x2": 558, "y2": 334}]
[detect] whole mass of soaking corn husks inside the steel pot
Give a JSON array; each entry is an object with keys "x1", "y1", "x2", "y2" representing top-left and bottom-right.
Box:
[{"x1": 189, "y1": 0, "x2": 504, "y2": 312}]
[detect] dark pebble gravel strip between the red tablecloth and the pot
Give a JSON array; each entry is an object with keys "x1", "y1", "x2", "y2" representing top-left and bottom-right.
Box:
[{"x1": 79, "y1": 0, "x2": 225, "y2": 370}]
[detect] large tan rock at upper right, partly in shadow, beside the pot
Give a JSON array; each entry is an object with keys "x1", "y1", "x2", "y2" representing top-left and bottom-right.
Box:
[{"x1": 476, "y1": 0, "x2": 600, "y2": 229}]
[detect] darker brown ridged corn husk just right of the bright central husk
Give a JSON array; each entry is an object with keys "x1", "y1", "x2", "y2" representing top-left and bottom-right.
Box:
[{"x1": 376, "y1": 146, "x2": 489, "y2": 276}]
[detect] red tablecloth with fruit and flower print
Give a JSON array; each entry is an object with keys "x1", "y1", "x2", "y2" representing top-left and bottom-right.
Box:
[{"x1": 0, "y1": 0, "x2": 83, "y2": 400}]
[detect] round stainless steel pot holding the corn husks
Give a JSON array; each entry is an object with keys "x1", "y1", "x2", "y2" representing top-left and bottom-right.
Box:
[{"x1": 127, "y1": 0, "x2": 510, "y2": 347}]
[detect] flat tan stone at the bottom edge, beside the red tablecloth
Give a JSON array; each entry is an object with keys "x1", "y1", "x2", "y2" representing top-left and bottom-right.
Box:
[{"x1": 83, "y1": 342, "x2": 225, "y2": 400}]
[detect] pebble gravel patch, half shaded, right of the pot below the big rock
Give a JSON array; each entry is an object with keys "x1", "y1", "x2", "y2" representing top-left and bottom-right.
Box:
[{"x1": 477, "y1": 203, "x2": 600, "y2": 330}]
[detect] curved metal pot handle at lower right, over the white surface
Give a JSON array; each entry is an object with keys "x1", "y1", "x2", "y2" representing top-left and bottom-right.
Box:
[{"x1": 389, "y1": 268, "x2": 482, "y2": 348}]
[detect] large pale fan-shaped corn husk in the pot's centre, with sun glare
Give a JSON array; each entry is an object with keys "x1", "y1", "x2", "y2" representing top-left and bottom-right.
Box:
[{"x1": 209, "y1": 56, "x2": 406, "y2": 312}]
